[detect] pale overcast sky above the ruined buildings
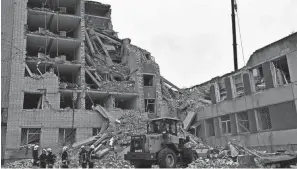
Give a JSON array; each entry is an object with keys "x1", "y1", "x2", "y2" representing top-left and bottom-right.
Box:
[{"x1": 98, "y1": 0, "x2": 297, "y2": 87}]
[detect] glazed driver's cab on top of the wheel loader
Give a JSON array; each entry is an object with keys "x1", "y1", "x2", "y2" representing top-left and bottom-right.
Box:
[{"x1": 147, "y1": 118, "x2": 180, "y2": 136}]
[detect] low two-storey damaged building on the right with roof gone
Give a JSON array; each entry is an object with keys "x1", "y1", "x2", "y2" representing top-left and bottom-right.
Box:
[{"x1": 180, "y1": 33, "x2": 297, "y2": 152}]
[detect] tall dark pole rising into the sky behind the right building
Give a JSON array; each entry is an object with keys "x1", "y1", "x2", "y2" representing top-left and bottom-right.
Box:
[{"x1": 231, "y1": 0, "x2": 238, "y2": 71}]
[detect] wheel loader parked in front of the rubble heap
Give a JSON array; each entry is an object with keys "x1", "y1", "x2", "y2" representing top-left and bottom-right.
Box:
[{"x1": 124, "y1": 117, "x2": 197, "y2": 168}]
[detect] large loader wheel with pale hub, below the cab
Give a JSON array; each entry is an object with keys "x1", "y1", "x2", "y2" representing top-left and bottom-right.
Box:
[{"x1": 158, "y1": 148, "x2": 177, "y2": 168}]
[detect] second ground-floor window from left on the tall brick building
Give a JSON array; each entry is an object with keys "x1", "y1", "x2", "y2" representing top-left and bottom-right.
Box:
[{"x1": 59, "y1": 128, "x2": 76, "y2": 146}]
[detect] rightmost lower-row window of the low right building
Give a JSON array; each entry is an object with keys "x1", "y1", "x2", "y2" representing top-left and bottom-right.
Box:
[{"x1": 257, "y1": 107, "x2": 272, "y2": 130}]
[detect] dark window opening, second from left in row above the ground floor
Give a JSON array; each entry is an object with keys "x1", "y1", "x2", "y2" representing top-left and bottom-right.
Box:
[{"x1": 60, "y1": 92, "x2": 80, "y2": 109}]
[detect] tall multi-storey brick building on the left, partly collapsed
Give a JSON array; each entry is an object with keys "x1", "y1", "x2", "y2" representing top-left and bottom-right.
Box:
[{"x1": 1, "y1": 0, "x2": 168, "y2": 159}]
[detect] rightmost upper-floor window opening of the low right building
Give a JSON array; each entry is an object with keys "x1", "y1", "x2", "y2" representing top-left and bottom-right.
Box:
[{"x1": 273, "y1": 56, "x2": 291, "y2": 85}]
